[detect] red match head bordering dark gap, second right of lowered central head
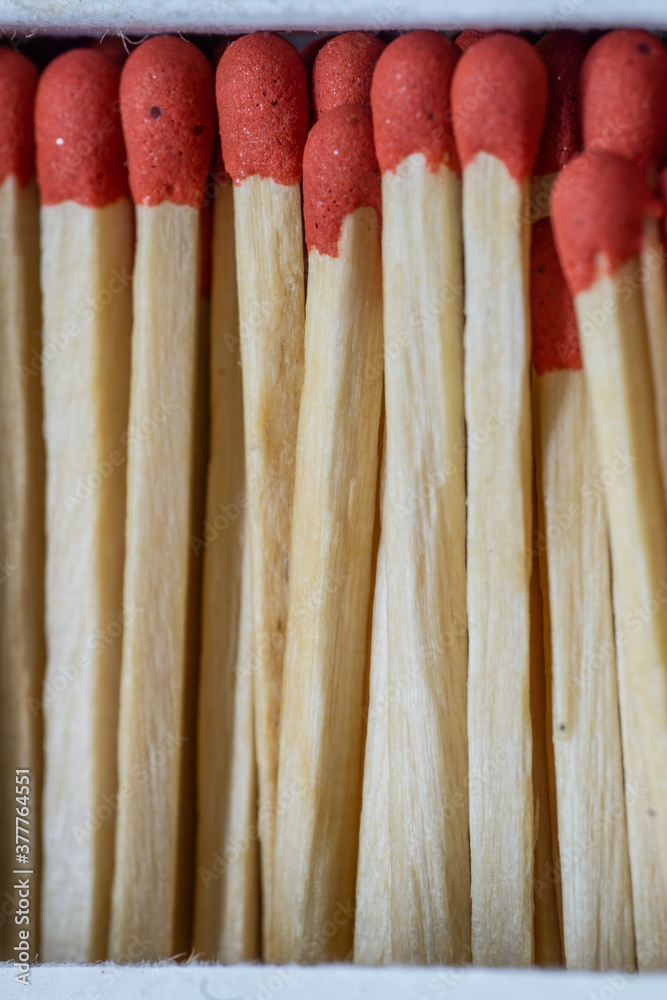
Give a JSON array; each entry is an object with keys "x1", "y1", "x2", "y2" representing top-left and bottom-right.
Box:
[{"x1": 452, "y1": 32, "x2": 547, "y2": 183}]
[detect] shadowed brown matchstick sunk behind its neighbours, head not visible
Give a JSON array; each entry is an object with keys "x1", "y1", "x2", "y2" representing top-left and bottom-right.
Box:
[{"x1": 193, "y1": 150, "x2": 259, "y2": 963}]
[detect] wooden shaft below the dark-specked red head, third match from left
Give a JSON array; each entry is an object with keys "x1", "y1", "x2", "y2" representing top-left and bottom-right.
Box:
[{"x1": 109, "y1": 202, "x2": 199, "y2": 960}]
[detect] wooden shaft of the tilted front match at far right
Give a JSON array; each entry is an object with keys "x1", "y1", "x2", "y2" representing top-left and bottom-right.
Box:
[{"x1": 575, "y1": 258, "x2": 667, "y2": 970}]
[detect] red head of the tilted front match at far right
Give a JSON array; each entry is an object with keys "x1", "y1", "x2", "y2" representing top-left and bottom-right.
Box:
[{"x1": 551, "y1": 153, "x2": 662, "y2": 296}]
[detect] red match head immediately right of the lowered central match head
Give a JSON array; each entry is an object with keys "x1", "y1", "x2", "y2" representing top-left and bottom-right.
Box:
[{"x1": 371, "y1": 31, "x2": 460, "y2": 173}]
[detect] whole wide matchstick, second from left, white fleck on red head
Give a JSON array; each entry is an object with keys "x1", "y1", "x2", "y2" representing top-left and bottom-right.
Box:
[{"x1": 35, "y1": 49, "x2": 136, "y2": 962}]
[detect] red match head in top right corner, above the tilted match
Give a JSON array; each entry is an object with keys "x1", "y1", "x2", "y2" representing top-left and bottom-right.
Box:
[{"x1": 581, "y1": 29, "x2": 667, "y2": 169}]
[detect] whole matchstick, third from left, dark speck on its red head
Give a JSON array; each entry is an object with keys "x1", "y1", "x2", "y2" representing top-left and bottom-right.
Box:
[{"x1": 109, "y1": 37, "x2": 215, "y2": 960}]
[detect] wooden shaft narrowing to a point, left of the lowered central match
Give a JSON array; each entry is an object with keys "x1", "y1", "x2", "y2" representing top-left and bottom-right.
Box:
[{"x1": 234, "y1": 176, "x2": 305, "y2": 948}]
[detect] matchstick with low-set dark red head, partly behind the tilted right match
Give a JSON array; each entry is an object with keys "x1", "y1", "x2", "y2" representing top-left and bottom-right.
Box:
[{"x1": 531, "y1": 219, "x2": 635, "y2": 970}]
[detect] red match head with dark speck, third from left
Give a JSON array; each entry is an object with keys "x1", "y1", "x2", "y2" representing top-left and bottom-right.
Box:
[{"x1": 120, "y1": 35, "x2": 215, "y2": 208}]
